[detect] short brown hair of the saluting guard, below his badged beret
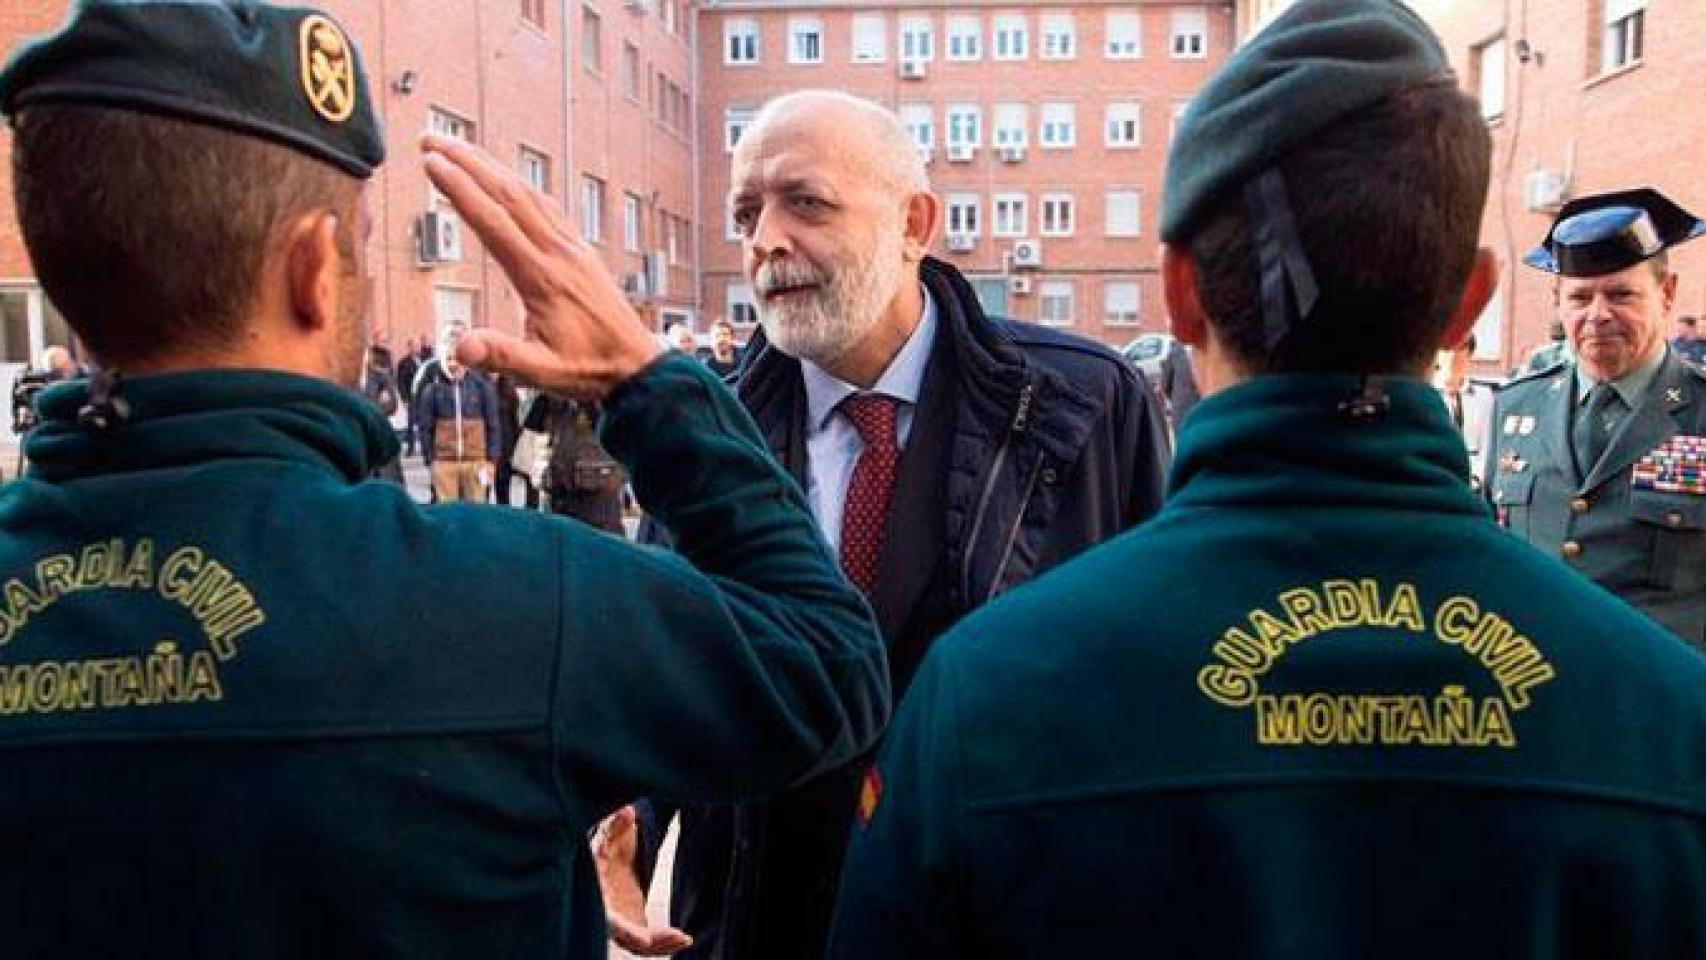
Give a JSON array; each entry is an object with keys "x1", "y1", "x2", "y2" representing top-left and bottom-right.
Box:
[{"x1": 12, "y1": 104, "x2": 362, "y2": 365}]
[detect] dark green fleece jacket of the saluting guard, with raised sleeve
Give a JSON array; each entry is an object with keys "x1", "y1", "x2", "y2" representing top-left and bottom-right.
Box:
[{"x1": 0, "y1": 358, "x2": 887, "y2": 960}]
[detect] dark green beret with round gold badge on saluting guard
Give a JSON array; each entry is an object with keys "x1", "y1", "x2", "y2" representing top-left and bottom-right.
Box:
[{"x1": 0, "y1": 0, "x2": 386, "y2": 179}]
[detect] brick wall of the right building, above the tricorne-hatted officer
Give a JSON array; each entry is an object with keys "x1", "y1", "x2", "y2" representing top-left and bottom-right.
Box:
[{"x1": 1416, "y1": 0, "x2": 1706, "y2": 372}]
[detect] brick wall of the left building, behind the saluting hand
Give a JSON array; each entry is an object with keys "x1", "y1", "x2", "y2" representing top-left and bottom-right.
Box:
[{"x1": 0, "y1": 0, "x2": 694, "y2": 361}]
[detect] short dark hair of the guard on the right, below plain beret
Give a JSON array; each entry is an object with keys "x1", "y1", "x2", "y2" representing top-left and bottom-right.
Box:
[{"x1": 1186, "y1": 77, "x2": 1491, "y2": 373}]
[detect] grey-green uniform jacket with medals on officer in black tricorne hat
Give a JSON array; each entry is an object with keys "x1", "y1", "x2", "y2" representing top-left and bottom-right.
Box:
[{"x1": 1483, "y1": 353, "x2": 1706, "y2": 648}]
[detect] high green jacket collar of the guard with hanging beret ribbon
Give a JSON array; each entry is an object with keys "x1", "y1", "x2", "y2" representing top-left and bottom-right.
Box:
[{"x1": 1167, "y1": 373, "x2": 1486, "y2": 513}]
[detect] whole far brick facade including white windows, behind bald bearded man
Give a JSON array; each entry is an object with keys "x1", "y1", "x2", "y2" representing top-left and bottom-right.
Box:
[{"x1": 699, "y1": 0, "x2": 1233, "y2": 344}]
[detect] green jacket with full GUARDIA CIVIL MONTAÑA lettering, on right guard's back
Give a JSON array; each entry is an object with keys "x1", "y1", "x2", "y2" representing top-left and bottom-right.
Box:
[{"x1": 831, "y1": 377, "x2": 1706, "y2": 960}]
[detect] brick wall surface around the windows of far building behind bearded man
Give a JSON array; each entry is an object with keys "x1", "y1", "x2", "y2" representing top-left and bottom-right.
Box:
[{"x1": 699, "y1": 2, "x2": 1233, "y2": 344}]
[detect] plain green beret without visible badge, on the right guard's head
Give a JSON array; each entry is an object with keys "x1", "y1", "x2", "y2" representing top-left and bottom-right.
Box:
[{"x1": 1162, "y1": 0, "x2": 1450, "y2": 244}]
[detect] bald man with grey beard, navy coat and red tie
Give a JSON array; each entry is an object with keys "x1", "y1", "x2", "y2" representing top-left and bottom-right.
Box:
[{"x1": 618, "y1": 90, "x2": 1169, "y2": 960}]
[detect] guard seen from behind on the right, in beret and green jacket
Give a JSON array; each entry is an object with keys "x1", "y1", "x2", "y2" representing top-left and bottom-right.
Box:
[{"x1": 832, "y1": 0, "x2": 1706, "y2": 960}]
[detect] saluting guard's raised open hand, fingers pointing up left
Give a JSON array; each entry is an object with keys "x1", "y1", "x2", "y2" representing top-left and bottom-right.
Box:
[{"x1": 421, "y1": 136, "x2": 664, "y2": 401}]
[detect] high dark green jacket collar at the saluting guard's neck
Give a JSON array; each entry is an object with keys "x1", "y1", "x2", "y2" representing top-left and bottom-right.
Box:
[{"x1": 24, "y1": 370, "x2": 397, "y2": 481}]
